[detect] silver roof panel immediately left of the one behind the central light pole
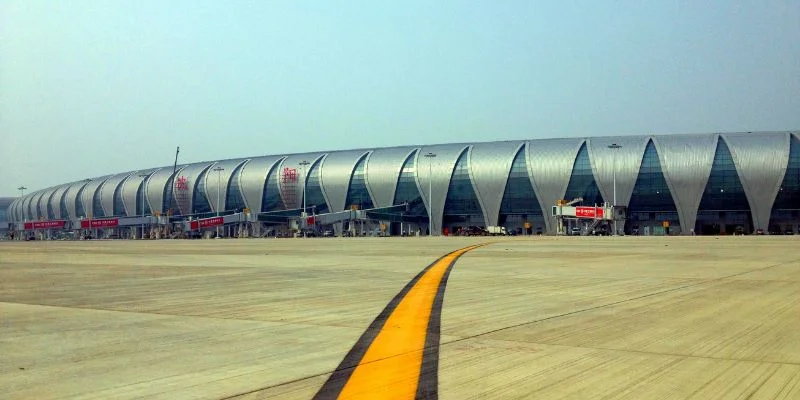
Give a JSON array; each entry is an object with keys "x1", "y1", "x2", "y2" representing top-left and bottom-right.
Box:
[{"x1": 364, "y1": 147, "x2": 418, "y2": 207}]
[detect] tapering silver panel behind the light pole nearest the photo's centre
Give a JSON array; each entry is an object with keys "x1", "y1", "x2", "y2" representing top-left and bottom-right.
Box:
[{"x1": 416, "y1": 143, "x2": 469, "y2": 235}]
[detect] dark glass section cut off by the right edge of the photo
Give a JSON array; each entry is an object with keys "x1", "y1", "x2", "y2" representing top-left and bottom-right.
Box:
[{"x1": 769, "y1": 135, "x2": 800, "y2": 234}]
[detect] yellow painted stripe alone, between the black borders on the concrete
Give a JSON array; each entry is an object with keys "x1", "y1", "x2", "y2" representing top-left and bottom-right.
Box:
[{"x1": 339, "y1": 246, "x2": 480, "y2": 399}]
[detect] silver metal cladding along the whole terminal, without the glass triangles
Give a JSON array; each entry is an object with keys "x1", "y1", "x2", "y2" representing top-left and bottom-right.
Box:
[{"x1": 9, "y1": 132, "x2": 800, "y2": 233}]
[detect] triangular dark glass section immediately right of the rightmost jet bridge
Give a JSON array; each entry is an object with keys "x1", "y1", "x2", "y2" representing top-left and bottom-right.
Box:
[{"x1": 625, "y1": 141, "x2": 680, "y2": 235}]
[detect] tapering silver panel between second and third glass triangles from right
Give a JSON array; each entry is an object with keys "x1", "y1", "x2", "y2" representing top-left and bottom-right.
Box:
[{"x1": 652, "y1": 134, "x2": 719, "y2": 232}]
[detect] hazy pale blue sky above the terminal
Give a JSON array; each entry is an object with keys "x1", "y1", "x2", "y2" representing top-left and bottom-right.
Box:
[{"x1": 0, "y1": 0, "x2": 800, "y2": 196}]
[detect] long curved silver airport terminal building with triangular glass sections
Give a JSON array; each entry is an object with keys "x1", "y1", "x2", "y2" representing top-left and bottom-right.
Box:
[{"x1": 7, "y1": 132, "x2": 800, "y2": 237}]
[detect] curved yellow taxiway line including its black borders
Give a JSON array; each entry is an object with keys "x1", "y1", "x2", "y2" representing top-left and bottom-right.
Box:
[{"x1": 315, "y1": 244, "x2": 485, "y2": 399}]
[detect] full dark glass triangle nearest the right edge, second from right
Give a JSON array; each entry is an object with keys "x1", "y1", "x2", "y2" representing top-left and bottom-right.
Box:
[{"x1": 695, "y1": 138, "x2": 753, "y2": 235}]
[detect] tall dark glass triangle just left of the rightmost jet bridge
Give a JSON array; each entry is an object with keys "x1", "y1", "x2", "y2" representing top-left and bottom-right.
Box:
[{"x1": 498, "y1": 147, "x2": 546, "y2": 235}]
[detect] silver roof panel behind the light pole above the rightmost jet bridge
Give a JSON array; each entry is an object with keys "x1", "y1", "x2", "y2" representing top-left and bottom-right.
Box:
[{"x1": 587, "y1": 136, "x2": 650, "y2": 206}]
